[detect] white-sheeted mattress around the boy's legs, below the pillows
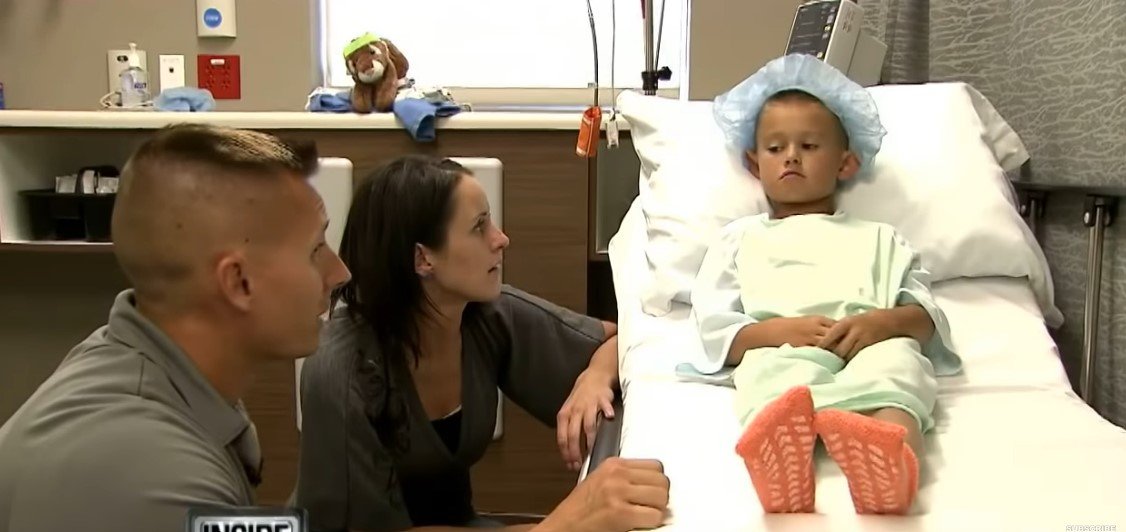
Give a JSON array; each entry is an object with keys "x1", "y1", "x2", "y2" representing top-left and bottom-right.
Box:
[{"x1": 616, "y1": 276, "x2": 1126, "y2": 531}]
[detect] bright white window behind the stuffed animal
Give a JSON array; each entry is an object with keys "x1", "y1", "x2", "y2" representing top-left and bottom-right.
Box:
[{"x1": 322, "y1": 0, "x2": 688, "y2": 104}]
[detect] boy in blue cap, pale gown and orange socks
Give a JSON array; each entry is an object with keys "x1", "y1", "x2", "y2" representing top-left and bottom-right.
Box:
[{"x1": 691, "y1": 55, "x2": 960, "y2": 514}]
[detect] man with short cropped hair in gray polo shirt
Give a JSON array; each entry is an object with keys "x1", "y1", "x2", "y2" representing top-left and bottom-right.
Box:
[{"x1": 0, "y1": 125, "x2": 349, "y2": 532}]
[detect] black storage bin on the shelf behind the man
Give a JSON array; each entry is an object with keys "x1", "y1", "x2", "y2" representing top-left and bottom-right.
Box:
[{"x1": 19, "y1": 188, "x2": 117, "y2": 242}]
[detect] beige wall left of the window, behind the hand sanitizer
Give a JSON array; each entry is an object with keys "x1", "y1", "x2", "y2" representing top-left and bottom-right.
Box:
[{"x1": 0, "y1": 0, "x2": 320, "y2": 110}]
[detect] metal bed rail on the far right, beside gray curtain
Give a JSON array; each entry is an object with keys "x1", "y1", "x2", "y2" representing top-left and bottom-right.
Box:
[{"x1": 1011, "y1": 176, "x2": 1126, "y2": 405}]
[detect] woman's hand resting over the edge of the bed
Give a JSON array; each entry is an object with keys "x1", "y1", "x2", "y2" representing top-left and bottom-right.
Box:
[{"x1": 555, "y1": 367, "x2": 617, "y2": 471}]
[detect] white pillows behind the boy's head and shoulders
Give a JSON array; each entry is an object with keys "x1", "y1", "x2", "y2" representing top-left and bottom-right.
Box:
[{"x1": 618, "y1": 83, "x2": 1057, "y2": 322}]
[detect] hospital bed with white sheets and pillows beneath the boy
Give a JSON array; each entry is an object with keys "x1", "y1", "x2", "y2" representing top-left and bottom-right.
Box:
[{"x1": 588, "y1": 83, "x2": 1126, "y2": 531}]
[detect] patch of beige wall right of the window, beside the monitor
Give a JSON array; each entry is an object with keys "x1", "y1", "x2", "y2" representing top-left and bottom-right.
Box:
[{"x1": 688, "y1": 0, "x2": 805, "y2": 99}]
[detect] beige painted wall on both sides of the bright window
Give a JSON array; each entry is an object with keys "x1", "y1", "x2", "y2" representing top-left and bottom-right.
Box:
[{"x1": 0, "y1": 0, "x2": 803, "y2": 110}]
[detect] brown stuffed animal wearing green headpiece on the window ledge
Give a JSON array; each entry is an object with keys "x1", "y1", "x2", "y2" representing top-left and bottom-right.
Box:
[{"x1": 345, "y1": 33, "x2": 410, "y2": 113}]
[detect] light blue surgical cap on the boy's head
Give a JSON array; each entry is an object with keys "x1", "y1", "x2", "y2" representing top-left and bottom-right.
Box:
[{"x1": 713, "y1": 54, "x2": 887, "y2": 170}]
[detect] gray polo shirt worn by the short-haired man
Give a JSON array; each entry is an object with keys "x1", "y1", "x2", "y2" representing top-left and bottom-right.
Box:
[{"x1": 0, "y1": 291, "x2": 260, "y2": 532}]
